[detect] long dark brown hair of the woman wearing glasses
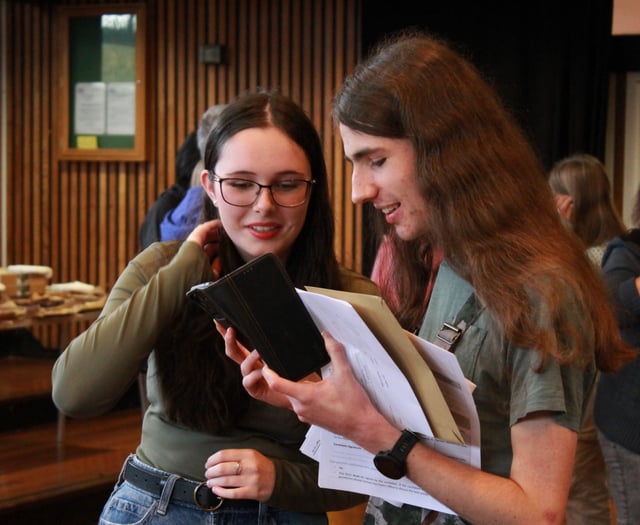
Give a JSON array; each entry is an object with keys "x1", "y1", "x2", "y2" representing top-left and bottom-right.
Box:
[{"x1": 155, "y1": 90, "x2": 340, "y2": 433}]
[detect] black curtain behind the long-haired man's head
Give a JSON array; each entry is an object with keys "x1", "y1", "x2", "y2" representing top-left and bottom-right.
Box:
[{"x1": 362, "y1": 0, "x2": 613, "y2": 272}]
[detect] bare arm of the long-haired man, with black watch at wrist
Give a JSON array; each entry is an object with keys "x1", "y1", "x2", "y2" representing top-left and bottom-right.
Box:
[{"x1": 349, "y1": 410, "x2": 576, "y2": 525}]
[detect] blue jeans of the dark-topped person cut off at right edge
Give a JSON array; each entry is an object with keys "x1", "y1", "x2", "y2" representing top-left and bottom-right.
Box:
[{"x1": 598, "y1": 431, "x2": 640, "y2": 525}]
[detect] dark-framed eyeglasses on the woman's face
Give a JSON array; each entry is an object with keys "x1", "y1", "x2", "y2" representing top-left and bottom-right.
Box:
[{"x1": 213, "y1": 176, "x2": 316, "y2": 208}]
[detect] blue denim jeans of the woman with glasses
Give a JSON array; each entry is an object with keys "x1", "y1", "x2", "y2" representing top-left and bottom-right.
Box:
[{"x1": 99, "y1": 458, "x2": 328, "y2": 525}]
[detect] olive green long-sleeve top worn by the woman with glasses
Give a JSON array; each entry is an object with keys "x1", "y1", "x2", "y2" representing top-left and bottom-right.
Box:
[{"x1": 52, "y1": 241, "x2": 379, "y2": 512}]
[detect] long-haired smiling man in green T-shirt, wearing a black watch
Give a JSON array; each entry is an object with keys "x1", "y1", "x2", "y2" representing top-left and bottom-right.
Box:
[{"x1": 221, "y1": 33, "x2": 633, "y2": 525}]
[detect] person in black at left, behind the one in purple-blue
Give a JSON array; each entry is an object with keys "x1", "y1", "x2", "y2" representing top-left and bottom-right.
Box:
[{"x1": 138, "y1": 131, "x2": 200, "y2": 250}]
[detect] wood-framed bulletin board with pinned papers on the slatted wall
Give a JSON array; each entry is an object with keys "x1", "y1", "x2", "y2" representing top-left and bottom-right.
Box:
[{"x1": 54, "y1": 4, "x2": 147, "y2": 161}]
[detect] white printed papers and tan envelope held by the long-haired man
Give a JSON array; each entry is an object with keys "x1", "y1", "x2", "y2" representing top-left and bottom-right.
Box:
[{"x1": 298, "y1": 288, "x2": 480, "y2": 514}]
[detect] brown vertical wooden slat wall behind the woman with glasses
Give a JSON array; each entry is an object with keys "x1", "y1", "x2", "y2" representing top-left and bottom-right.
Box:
[{"x1": 6, "y1": 0, "x2": 362, "y2": 346}]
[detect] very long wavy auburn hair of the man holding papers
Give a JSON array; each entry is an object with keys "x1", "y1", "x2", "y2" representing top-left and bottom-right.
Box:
[{"x1": 334, "y1": 32, "x2": 632, "y2": 370}]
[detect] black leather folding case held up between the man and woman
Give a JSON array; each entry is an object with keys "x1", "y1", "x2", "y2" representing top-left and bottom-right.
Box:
[{"x1": 187, "y1": 253, "x2": 329, "y2": 381}]
